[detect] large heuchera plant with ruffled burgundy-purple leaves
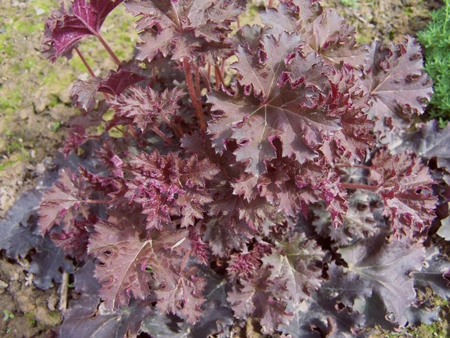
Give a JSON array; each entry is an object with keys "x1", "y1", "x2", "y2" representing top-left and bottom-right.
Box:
[{"x1": 39, "y1": 0, "x2": 450, "y2": 337}]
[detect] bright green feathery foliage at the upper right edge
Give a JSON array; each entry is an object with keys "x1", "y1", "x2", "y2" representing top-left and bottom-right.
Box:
[{"x1": 418, "y1": 0, "x2": 450, "y2": 124}]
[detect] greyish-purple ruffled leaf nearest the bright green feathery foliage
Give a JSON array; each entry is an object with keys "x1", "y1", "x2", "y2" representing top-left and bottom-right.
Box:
[{"x1": 364, "y1": 37, "x2": 433, "y2": 137}]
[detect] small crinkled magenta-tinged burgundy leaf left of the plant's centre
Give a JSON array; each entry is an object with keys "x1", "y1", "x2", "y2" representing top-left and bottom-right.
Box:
[{"x1": 126, "y1": 151, "x2": 218, "y2": 229}]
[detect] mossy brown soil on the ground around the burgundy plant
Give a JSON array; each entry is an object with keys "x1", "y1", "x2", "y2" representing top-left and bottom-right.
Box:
[{"x1": 0, "y1": 0, "x2": 442, "y2": 337}]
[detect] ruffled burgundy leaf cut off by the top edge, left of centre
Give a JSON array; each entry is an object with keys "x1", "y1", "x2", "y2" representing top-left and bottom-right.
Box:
[{"x1": 126, "y1": 0, "x2": 243, "y2": 61}]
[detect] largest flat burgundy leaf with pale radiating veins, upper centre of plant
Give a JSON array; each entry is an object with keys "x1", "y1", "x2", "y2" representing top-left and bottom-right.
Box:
[{"x1": 208, "y1": 33, "x2": 371, "y2": 175}]
